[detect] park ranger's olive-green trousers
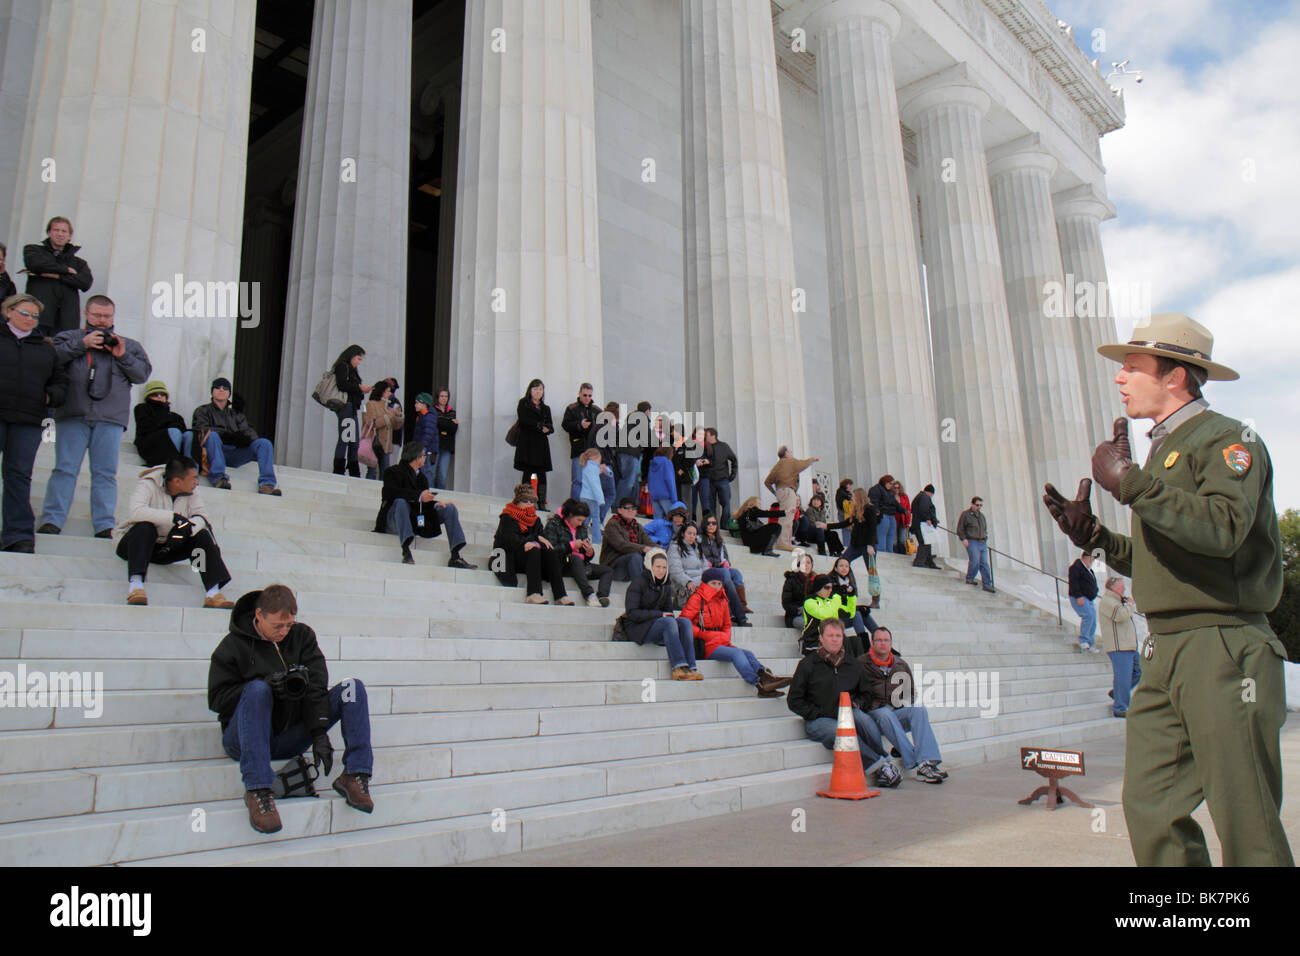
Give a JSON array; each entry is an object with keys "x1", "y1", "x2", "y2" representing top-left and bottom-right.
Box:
[{"x1": 1123, "y1": 626, "x2": 1295, "y2": 866}]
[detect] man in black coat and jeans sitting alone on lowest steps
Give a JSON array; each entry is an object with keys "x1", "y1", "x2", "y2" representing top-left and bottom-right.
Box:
[{"x1": 208, "y1": 584, "x2": 374, "y2": 834}]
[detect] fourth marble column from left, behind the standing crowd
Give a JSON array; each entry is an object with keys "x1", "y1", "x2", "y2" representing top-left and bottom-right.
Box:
[{"x1": 681, "y1": 0, "x2": 816, "y2": 488}]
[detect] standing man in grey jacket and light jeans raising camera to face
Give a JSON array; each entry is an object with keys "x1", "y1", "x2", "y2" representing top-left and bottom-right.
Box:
[{"x1": 36, "y1": 295, "x2": 153, "y2": 537}]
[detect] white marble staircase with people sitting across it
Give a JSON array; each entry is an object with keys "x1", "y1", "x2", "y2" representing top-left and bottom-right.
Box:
[{"x1": 0, "y1": 445, "x2": 1122, "y2": 865}]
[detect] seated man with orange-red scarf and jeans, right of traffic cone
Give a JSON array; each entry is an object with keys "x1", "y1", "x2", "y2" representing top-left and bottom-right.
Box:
[{"x1": 858, "y1": 627, "x2": 948, "y2": 783}]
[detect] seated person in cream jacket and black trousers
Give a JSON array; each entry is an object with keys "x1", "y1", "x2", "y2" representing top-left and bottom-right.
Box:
[{"x1": 113, "y1": 455, "x2": 234, "y2": 607}]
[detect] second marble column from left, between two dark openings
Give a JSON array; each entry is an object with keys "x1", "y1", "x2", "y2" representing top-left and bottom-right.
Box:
[{"x1": 276, "y1": 0, "x2": 412, "y2": 468}]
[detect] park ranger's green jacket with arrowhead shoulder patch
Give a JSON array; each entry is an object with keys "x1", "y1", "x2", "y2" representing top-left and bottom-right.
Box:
[{"x1": 1088, "y1": 410, "x2": 1282, "y2": 633}]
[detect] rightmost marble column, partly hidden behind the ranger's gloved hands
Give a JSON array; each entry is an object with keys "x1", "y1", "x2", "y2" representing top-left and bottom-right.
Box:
[{"x1": 1052, "y1": 185, "x2": 1130, "y2": 531}]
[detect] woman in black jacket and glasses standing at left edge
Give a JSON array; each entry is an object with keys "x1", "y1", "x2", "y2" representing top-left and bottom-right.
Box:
[{"x1": 0, "y1": 294, "x2": 68, "y2": 554}]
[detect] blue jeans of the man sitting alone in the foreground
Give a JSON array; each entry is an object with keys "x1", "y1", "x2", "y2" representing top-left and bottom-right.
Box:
[{"x1": 221, "y1": 678, "x2": 374, "y2": 790}]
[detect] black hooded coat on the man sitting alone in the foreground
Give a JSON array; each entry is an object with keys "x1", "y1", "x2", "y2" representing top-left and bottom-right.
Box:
[{"x1": 208, "y1": 591, "x2": 329, "y2": 736}]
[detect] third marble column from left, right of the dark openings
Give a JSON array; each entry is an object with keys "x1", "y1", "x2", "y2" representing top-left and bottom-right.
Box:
[{"x1": 451, "y1": 0, "x2": 605, "y2": 503}]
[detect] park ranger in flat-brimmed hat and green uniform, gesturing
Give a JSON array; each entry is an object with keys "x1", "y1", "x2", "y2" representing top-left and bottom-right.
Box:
[{"x1": 1043, "y1": 313, "x2": 1294, "y2": 866}]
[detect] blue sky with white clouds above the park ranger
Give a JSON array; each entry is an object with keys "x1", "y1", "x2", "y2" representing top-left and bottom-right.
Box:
[{"x1": 1048, "y1": 0, "x2": 1300, "y2": 511}]
